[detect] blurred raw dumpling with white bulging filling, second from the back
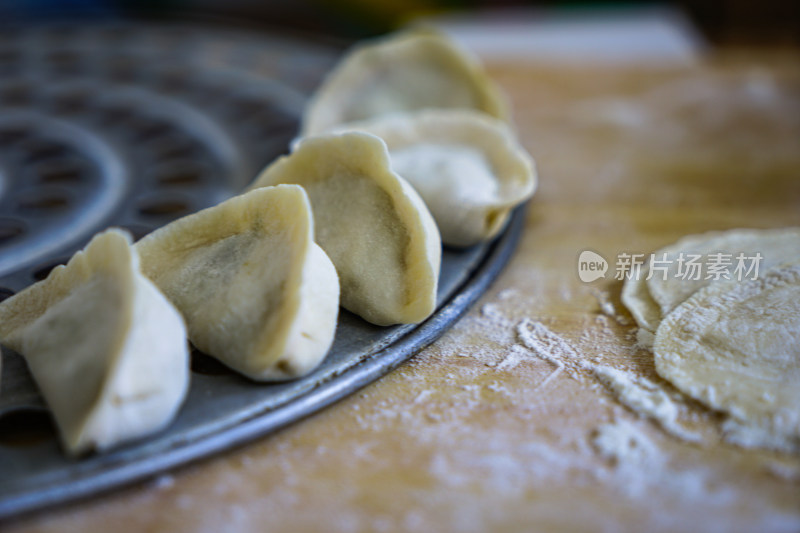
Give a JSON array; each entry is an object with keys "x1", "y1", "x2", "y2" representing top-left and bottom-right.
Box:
[{"x1": 334, "y1": 109, "x2": 536, "y2": 246}]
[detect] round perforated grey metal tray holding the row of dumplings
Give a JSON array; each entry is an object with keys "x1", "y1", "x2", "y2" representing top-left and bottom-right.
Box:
[{"x1": 0, "y1": 22, "x2": 524, "y2": 519}]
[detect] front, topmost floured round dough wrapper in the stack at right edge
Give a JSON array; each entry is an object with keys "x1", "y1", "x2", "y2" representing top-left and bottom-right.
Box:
[{"x1": 654, "y1": 261, "x2": 800, "y2": 451}]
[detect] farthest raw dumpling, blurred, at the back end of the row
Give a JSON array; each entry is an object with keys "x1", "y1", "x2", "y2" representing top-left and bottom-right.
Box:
[{"x1": 302, "y1": 30, "x2": 508, "y2": 136}]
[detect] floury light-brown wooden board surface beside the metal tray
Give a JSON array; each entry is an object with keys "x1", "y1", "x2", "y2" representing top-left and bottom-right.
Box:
[{"x1": 3, "y1": 54, "x2": 800, "y2": 533}]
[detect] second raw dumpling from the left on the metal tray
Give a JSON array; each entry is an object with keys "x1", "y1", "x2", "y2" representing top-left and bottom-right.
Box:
[{"x1": 136, "y1": 185, "x2": 339, "y2": 380}]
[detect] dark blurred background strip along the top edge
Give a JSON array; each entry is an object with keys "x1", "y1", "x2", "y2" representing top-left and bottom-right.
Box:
[{"x1": 0, "y1": 0, "x2": 800, "y2": 47}]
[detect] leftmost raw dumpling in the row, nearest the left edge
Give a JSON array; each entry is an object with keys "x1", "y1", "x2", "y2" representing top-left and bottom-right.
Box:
[{"x1": 0, "y1": 230, "x2": 189, "y2": 455}]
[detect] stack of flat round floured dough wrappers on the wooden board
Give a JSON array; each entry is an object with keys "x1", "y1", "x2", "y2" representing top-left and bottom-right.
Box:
[{"x1": 622, "y1": 228, "x2": 800, "y2": 453}]
